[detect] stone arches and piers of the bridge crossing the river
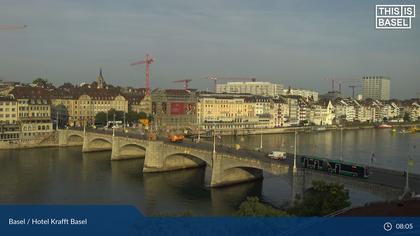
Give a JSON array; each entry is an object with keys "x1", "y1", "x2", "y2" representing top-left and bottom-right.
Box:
[{"x1": 58, "y1": 130, "x2": 289, "y2": 187}]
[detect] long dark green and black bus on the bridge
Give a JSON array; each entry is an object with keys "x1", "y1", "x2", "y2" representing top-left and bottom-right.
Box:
[{"x1": 301, "y1": 156, "x2": 369, "y2": 179}]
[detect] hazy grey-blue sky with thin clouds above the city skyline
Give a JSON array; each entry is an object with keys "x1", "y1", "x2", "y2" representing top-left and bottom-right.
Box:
[{"x1": 0, "y1": 0, "x2": 420, "y2": 99}]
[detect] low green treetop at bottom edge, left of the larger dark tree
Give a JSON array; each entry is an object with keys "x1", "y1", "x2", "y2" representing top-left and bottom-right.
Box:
[{"x1": 235, "y1": 197, "x2": 287, "y2": 216}]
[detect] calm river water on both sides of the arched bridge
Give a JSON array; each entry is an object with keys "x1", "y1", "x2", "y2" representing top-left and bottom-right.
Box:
[{"x1": 0, "y1": 129, "x2": 420, "y2": 215}]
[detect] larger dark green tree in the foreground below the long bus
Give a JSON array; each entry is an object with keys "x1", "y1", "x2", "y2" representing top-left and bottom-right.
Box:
[{"x1": 288, "y1": 181, "x2": 351, "y2": 216}]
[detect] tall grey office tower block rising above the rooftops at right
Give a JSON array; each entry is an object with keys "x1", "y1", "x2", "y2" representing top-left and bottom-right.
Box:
[{"x1": 362, "y1": 76, "x2": 390, "y2": 100}]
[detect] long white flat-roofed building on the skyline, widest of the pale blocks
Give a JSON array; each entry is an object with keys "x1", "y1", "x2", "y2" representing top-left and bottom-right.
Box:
[{"x1": 216, "y1": 81, "x2": 283, "y2": 96}]
